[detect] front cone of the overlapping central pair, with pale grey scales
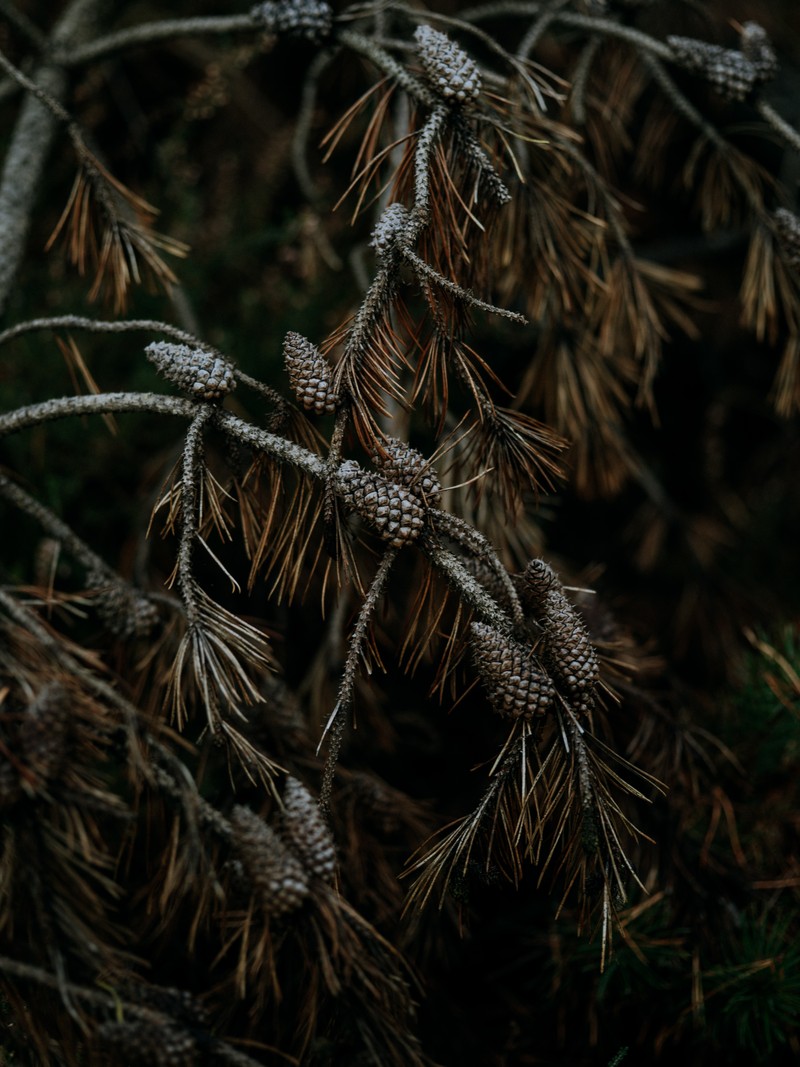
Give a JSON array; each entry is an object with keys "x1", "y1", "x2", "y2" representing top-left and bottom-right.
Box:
[{"x1": 335, "y1": 460, "x2": 425, "y2": 548}]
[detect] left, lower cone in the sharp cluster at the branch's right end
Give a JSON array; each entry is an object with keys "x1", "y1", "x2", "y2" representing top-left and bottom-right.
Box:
[{"x1": 469, "y1": 622, "x2": 555, "y2": 720}]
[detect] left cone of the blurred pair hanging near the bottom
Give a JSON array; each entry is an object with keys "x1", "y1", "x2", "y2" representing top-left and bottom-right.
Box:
[{"x1": 230, "y1": 806, "x2": 308, "y2": 918}]
